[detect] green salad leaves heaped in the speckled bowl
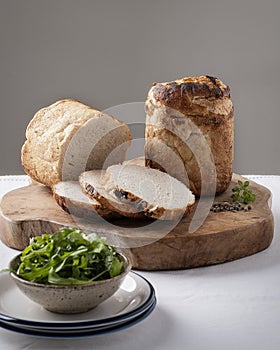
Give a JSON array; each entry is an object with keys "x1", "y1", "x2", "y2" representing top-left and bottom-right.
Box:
[{"x1": 16, "y1": 227, "x2": 123, "y2": 285}]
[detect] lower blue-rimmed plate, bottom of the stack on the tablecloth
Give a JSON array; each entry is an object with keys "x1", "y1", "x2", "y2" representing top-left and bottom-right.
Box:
[{"x1": 0, "y1": 298, "x2": 156, "y2": 339}]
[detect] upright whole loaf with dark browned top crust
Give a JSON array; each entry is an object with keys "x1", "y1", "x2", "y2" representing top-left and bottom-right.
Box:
[{"x1": 145, "y1": 76, "x2": 234, "y2": 195}]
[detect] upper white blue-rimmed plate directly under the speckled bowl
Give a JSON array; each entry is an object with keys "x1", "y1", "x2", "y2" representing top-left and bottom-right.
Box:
[{"x1": 0, "y1": 271, "x2": 155, "y2": 330}]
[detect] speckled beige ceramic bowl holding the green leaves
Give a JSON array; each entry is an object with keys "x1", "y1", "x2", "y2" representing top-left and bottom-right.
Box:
[{"x1": 9, "y1": 254, "x2": 131, "y2": 314}]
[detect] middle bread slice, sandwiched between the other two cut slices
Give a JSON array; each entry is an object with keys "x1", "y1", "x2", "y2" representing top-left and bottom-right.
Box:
[{"x1": 79, "y1": 170, "x2": 145, "y2": 218}]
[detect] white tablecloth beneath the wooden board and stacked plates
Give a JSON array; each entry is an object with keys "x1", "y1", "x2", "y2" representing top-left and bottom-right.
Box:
[{"x1": 0, "y1": 175, "x2": 280, "y2": 350}]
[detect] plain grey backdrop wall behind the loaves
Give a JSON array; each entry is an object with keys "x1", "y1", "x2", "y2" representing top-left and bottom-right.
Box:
[{"x1": 0, "y1": 0, "x2": 280, "y2": 175}]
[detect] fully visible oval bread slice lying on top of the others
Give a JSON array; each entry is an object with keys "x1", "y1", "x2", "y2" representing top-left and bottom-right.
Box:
[{"x1": 102, "y1": 165, "x2": 195, "y2": 220}]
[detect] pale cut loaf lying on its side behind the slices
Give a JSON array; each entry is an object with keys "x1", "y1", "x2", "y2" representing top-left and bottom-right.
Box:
[{"x1": 21, "y1": 99, "x2": 131, "y2": 187}]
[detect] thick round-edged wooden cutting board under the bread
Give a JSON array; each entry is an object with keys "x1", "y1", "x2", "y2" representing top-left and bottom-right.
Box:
[{"x1": 0, "y1": 174, "x2": 274, "y2": 270}]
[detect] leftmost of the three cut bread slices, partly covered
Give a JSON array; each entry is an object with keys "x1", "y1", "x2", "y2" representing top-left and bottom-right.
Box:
[{"x1": 52, "y1": 181, "x2": 118, "y2": 219}]
